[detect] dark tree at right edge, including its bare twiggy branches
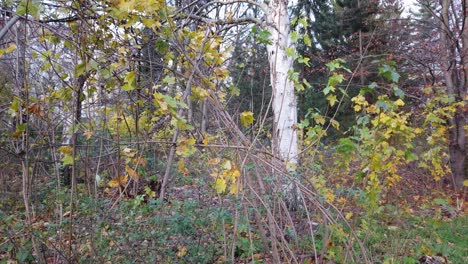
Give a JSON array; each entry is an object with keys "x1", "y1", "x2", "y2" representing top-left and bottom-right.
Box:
[{"x1": 409, "y1": 0, "x2": 468, "y2": 189}]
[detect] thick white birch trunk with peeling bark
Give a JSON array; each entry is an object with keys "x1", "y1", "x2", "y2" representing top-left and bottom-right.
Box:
[{"x1": 267, "y1": 0, "x2": 298, "y2": 168}]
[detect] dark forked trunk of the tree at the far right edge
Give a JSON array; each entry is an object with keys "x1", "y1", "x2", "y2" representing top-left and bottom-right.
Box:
[{"x1": 439, "y1": 0, "x2": 468, "y2": 189}]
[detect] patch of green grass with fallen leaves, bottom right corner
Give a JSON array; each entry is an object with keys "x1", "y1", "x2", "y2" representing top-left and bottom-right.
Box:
[{"x1": 366, "y1": 212, "x2": 468, "y2": 264}]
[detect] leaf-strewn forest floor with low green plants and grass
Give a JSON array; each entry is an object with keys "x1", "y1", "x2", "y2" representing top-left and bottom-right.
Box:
[{"x1": 0, "y1": 164, "x2": 468, "y2": 264}]
